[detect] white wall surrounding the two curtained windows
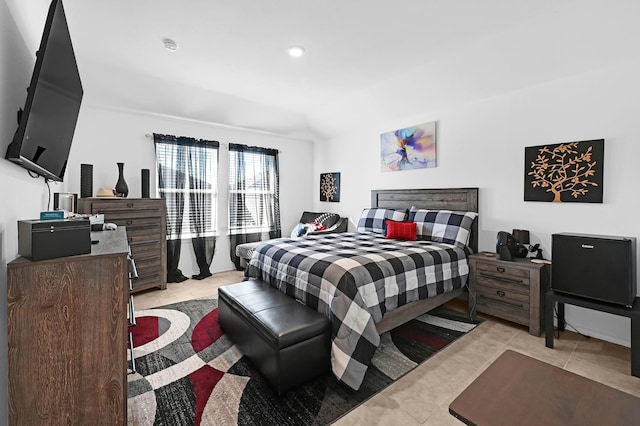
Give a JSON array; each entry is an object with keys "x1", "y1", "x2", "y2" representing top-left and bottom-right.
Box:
[{"x1": 65, "y1": 105, "x2": 313, "y2": 276}]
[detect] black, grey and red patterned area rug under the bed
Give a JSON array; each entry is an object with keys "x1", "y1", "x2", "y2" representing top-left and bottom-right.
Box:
[{"x1": 128, "y1": 299, "x2": 477, "y2": 426}]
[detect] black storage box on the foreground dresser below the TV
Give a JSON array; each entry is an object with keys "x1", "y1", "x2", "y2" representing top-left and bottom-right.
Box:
[{"x1": 18, "y1": 219, "x2": 91, "y2": 260}]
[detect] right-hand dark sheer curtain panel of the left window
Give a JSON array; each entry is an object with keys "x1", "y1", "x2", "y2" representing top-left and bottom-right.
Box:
[{"x1": 189, "y1": 143, "x2": 218, "y2": 280}]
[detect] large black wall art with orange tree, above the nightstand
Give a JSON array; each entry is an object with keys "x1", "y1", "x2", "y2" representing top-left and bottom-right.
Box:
[{"x1": 524, "y1": 139, "x2": 604, "y2": 203}]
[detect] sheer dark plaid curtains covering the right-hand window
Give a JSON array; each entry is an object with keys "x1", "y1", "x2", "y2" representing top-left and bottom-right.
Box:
[{"x1": 229, "y1": 144, "x2": 282, "y2": 270}]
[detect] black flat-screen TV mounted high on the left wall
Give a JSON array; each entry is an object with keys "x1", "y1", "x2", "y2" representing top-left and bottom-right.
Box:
[{"x1": 6, "y1": 0, "x2": 84, "y2": 181}]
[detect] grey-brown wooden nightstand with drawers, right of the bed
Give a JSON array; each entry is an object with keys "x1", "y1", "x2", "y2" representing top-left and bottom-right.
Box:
[{"x1": 469, "y1": 253, "x2": 551, "y2": 336}]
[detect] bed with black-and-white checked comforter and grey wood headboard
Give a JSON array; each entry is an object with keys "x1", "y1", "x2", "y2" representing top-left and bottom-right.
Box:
[{"x1": 245, "y1": 188, "x2": 478, "y2": 390}]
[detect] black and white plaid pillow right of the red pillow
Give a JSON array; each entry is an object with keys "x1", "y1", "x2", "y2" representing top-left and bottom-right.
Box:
[{"x1": 409, "y1": 209, "x2": 478, "y2": 247}]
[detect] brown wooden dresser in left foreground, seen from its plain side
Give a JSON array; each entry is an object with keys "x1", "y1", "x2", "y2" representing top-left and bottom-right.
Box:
[{"x1": 7, "y1": 228, "x2": 129, "y2": 425}]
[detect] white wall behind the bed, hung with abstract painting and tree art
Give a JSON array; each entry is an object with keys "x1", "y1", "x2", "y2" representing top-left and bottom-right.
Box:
[{"x1": 315, "y1": 28, "x2": 640, "y2": 346}]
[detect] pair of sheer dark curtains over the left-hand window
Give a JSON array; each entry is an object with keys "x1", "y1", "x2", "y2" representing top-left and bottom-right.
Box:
[{"x1": 153, "y1": 133, "x2": 219, "y2": 282}]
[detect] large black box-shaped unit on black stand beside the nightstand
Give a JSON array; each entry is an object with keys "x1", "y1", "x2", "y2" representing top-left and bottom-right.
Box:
[{"x1": 551, "y1": 233, "x2": 637, "y2": 306}]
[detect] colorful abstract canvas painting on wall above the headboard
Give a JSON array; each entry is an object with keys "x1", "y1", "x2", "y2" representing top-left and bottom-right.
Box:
[{"x1": 380, "y1": 121, "x2": 437, "y2": 172}]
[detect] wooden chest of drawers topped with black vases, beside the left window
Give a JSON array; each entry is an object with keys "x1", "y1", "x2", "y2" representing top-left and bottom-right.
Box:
[{"x1": 78, "y1": 198, "x2": 167, "y2": 292}]
